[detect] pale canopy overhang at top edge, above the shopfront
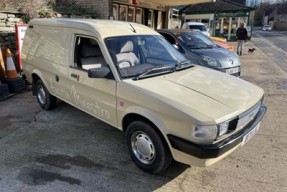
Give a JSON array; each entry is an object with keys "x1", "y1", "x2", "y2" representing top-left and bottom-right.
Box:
[{"x1": 144, "y1": 0, "x2": 216, "y2": 6}]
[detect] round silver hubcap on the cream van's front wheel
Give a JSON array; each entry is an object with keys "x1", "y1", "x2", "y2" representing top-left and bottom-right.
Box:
[{"x1": 131, "y1": 131, "x2": 156, "y2": 164}]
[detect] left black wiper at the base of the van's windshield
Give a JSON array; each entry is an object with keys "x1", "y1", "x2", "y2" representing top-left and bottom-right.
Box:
[{"x1": 133, "y1": 65, "x2": 174, "y2": 80}]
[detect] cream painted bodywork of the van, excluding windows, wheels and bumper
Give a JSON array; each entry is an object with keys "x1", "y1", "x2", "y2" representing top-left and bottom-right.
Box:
[{"x1": 22, "y1": 19, "x2": 263, "y2": 166}]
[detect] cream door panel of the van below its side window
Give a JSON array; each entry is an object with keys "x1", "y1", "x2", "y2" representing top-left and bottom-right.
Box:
[{"x1": 69, "y1": 68, "x2": 117, "y2": 126}]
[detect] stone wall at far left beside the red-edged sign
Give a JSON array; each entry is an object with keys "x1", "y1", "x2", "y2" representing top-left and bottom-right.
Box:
[{"x1": 0, "y1": 12, "x2": 23, "y2": 54}]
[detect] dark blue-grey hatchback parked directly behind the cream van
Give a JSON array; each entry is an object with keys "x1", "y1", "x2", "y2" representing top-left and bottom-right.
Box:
[{"x1": 158, "y1": 29, "x2": 241, "y2": 77}]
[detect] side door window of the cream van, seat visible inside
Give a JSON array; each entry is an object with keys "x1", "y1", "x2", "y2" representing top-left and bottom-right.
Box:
[{"x1": 74, "y1": 36, "x2": 106, "y2": 70}]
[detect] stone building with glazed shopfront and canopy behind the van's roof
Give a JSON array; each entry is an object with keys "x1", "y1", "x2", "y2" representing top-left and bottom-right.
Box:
[{"x1": 60, "y1": 0, "x2": 214, "y2": 29}]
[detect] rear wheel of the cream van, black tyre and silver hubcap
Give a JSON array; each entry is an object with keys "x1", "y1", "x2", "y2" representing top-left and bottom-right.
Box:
[{"x1": 35, "y1": 79, "x2": 57, "y2": 110}]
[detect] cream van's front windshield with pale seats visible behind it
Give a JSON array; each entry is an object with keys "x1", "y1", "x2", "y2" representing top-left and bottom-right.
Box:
[{"x1": 105, "y1": 35, "x2": 188, "y2": 79}]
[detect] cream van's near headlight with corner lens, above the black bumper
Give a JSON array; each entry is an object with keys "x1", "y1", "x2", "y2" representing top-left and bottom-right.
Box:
[{"x1": 191, "y1": 122, "x2": 229, "y2": 143}]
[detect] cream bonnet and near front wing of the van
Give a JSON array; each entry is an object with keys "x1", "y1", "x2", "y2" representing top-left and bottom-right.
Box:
[{"x1": 117, "y1": 66, "x2": 263, "y2": 144}]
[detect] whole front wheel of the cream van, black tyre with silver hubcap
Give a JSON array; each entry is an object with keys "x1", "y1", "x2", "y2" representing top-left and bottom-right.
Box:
[{"x1": 125, "y1": 121, "x2": 172, "y2": 173}]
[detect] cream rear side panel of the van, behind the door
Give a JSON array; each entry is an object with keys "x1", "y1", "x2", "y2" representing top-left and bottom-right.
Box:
[{"x1": 22, "y1": 25, "x2": 73, "y2": 94}]
